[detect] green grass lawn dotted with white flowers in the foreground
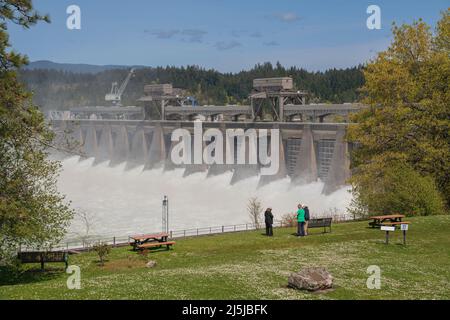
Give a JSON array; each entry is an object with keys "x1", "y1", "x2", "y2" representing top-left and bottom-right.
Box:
[{"x1": 0, "y1": 216, "x2": 450, "y2": 299}]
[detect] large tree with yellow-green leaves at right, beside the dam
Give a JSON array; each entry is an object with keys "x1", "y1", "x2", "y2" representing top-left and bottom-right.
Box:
[{"x1": 348, "y1": 10, "x2": 450, "y2": 218}]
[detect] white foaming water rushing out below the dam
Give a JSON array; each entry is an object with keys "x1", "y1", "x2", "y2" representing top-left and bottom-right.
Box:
[{"x1": 58, "y1": 157, "x2": 351, "y2": 241}]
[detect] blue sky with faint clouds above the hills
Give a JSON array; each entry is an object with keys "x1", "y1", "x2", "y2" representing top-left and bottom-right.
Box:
[{"x1": 9, "y1": 0, "x2": 449, "y2": 72}]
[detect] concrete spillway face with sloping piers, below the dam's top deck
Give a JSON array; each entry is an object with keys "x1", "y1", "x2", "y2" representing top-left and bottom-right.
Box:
[{"x1": 51, "y1": 120, "x2": 352, "y2": 194}]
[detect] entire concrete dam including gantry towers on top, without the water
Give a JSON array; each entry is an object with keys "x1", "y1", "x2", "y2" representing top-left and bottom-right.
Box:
[{"x1": 49, "y1": 77, "x2": 364, "y2": 198}]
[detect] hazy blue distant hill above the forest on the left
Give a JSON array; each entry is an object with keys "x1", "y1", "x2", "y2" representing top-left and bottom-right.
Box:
[{"x1": 23, "y1": 60, "x2": 143, "y2": 74}]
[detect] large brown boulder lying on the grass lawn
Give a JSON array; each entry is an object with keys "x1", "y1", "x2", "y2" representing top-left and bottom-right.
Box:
[{"x1": 288, "y1": 268, "x2": 333, "y2": 291}]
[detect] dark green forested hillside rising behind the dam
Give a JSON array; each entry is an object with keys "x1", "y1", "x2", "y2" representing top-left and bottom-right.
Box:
[{"x1": 20, "y1": 63, "x2": 364, "y2": 110}]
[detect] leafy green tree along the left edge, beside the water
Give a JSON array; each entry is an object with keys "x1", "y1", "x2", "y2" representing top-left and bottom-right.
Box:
[{"x1": 0, "y1": 0, "x2": 73, "y2": 262}]
